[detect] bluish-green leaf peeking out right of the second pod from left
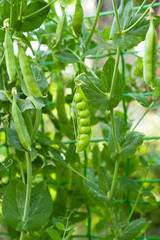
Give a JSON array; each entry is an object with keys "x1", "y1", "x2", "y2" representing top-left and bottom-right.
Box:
[{"x1": 32, "y1": 65, "x2": 48, "y2": 95}]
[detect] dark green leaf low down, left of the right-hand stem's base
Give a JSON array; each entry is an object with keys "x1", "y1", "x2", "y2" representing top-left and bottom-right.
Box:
[{"x1": 83, "y1": 181, "x2": 114, "y2": 207}]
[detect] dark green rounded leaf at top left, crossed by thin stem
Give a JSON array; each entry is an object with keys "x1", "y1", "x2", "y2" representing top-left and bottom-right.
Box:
[{"x1": 16, "y1": 1, "x2": 50, "y2": 32}]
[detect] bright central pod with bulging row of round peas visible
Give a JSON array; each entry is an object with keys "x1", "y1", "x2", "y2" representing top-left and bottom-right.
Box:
[{"x1": 74, "y1": 86, "x2": 91, "y2": 153}]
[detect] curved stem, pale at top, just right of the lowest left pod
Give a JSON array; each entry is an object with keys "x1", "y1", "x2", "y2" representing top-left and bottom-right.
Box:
[{"x1": 29, "y1": 96, "x2": 42, "y2": 142}]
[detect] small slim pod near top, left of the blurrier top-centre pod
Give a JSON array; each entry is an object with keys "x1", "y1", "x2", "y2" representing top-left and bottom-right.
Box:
[{"x1": 55, "y1": 11, "x2": 67, "y2": 47}]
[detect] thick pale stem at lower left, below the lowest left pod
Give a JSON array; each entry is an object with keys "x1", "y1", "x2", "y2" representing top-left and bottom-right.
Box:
[{"x1": 20, "y1": 152, "x2": 32, "y2": 240}]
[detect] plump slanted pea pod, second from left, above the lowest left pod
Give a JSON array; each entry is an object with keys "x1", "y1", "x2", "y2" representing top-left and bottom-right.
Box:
[{"x1": 18, "y1": 44, "x2": 43, "y2": 97}]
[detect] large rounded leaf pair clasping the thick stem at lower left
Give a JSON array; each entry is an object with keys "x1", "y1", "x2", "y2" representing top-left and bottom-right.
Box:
[{"x1": 2, "y1": 179, "x2": 52, "y2": 231}]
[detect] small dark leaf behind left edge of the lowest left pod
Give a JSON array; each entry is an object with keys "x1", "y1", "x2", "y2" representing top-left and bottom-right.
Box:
[{"x1": 7, "y1": 128, "x2": 25, "y2": 152}]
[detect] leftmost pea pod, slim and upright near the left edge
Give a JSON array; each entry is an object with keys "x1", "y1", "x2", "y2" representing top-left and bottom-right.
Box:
[{"x1": 4, "y1": 22, "x2": 16, "y2": 83}]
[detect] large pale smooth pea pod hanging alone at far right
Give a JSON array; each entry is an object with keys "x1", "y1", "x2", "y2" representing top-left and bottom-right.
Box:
[{"x1": 143, "y1": 9, "x2": 157, "y2": 88}]
